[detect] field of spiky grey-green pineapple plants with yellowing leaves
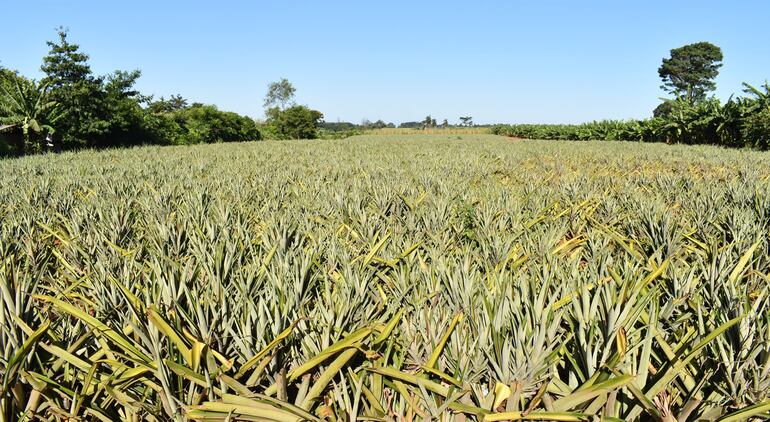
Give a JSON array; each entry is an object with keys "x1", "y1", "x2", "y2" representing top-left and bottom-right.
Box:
[{"x1": 0, "y1": 134, "x2": 770, "y2": 422}]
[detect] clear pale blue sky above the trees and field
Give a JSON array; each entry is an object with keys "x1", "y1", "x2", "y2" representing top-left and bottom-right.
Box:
[{"x1": 0, "y1": 0, "x2": 770, "y2": 123}]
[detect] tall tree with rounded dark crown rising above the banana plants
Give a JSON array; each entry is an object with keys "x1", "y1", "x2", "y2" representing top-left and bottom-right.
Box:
[{"x1": 658, "y1": 42, "x2": 723, "y2": 103}]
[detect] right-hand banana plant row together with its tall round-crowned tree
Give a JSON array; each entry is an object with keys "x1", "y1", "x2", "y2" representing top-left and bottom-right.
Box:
[{"x1": 492, "y1": 42, "x2": 770, "y2": 149}]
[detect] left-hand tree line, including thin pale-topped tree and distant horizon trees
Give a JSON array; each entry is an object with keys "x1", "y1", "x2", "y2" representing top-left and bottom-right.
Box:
[{"x1": 0, "y1": 28, "x2": 472, "y2": 156}]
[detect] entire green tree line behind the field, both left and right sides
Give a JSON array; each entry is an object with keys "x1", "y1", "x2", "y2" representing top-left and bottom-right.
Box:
[{"x1": 0, "y1": 35, "x2": 770, "y2": 156}]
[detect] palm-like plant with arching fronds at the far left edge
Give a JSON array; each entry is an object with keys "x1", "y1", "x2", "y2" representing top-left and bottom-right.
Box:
[{"x1": 0, "y1": 77, "x2": 60, "y2": 154}]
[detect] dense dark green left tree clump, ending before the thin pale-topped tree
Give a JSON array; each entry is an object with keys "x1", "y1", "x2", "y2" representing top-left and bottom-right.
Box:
[{"x1": 0, "y1": 30, "x2": 260, "y2": 155}]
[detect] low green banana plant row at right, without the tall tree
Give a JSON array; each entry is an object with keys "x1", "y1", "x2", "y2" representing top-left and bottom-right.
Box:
[{"x1": 492, "y1": 83, "x2": 770, "y2": 149}]
